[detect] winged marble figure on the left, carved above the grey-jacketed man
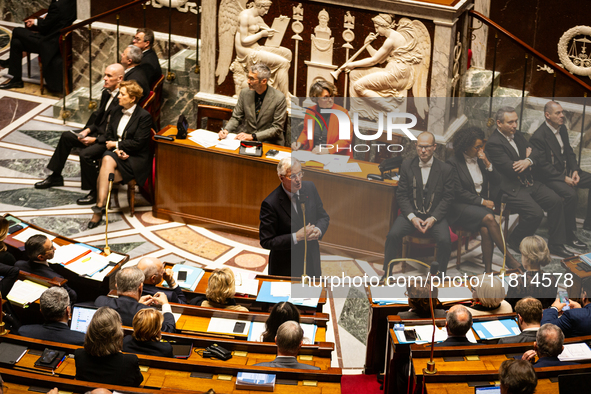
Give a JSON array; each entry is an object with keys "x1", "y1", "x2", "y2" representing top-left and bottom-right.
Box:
[{"x1": 216, "y1": 0, "x2": 292, "y2": 98}]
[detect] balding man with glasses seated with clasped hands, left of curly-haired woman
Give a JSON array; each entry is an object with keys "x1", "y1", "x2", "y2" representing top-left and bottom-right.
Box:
[{"x1": 384, "y1": 131, "x2": 455, "y2": 277}]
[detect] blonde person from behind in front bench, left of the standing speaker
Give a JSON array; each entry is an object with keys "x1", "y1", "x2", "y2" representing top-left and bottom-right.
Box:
[{"x1": 194, "y1": 267, "x2": 248, "y2": 312}]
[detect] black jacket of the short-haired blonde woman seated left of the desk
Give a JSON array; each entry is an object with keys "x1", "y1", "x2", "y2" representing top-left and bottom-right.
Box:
[{"x1": 106, "y1": 105, "x2": 153, "y2": 186}]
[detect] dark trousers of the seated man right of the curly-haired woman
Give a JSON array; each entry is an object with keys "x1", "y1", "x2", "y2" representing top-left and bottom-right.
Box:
[{"x1": 507, "y1": 181, "x2": 566, "y2": 245}]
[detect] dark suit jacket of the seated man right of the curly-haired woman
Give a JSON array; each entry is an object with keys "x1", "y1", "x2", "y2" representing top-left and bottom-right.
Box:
[{"x1": 484, "y1": 130, "x2": 538, "y2": 201}]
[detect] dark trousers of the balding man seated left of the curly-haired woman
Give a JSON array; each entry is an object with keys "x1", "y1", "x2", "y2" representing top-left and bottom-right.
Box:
[{"x1": 384, "y1": 215, "x2": 451, "y2": 273}]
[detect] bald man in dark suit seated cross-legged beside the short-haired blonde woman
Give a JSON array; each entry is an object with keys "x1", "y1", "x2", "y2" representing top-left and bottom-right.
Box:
[{"x1": 35, "y1": 63, "x2": 124, "y2": 205}]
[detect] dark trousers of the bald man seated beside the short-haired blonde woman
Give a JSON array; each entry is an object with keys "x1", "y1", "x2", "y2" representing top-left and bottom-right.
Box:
[{"x1": 47, "y1": 131, "x2": 107, "y2": 190}]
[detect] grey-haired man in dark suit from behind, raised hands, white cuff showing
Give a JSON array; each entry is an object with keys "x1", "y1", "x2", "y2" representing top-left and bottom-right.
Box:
[{"x1": 94, "y1": 267, "x2": 175, "y2": 332}]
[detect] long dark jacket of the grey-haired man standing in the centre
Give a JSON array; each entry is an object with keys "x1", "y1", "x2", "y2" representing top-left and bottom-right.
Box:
[{"x1": 259, "y1": 181, "x2": 330, "y2": 276}]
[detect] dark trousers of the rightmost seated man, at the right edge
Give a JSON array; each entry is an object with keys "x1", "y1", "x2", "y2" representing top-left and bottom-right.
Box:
[{"x1": 546, "y1": 171, "x2": 591, "y2": 235}]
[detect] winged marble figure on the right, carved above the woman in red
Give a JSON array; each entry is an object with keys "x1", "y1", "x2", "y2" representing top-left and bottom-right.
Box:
[{"x1": 341, "y1": 14, "x2": 431, "y2": 119}]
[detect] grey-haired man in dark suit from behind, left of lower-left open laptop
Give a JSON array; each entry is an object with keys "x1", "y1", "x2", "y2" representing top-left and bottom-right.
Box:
[{"x1": 18, "y1": 287, "x2": 84, "y2": 346}]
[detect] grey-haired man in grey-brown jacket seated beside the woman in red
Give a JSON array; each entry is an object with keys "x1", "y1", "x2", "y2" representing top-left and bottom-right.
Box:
[{"x1": 219, "y1": 63, "x2": 289, "y2": 145}]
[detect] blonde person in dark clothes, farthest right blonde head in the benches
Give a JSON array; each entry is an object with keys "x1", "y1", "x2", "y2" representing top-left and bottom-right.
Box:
[{"x1": 507, "y1": 235, "x2": 558, "y2": 309}]
